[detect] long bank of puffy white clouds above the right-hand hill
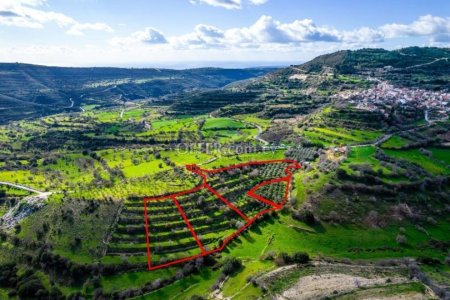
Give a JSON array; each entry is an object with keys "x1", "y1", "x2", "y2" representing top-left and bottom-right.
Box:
[{"x1": 143, "y1": 15, "x2": 450, "y2": 49}]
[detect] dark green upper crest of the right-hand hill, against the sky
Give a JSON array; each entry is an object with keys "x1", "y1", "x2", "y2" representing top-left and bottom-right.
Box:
[{"x1": 272, "y1": 47, "x2": 450, "y2": 89}]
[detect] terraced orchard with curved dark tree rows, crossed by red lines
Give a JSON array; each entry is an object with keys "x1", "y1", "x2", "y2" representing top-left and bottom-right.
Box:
[{"x1": 116, "y1": 160, "x2": 300, "y2": 270}]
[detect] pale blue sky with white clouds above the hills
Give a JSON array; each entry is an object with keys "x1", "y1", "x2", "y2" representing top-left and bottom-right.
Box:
[{"x1": 0, "y1": 0, "x2": 450, "y2": 67}]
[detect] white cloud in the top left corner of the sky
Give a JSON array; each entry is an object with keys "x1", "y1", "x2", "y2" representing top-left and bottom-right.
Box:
[{"x1": 0, "y1": 0, "x2": 113, "y2": 35}]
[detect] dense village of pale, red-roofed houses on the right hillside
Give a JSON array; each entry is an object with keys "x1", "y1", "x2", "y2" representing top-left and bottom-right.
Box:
[{"x1": 336, "y1": 82, "x2": 450, "y2": 119}]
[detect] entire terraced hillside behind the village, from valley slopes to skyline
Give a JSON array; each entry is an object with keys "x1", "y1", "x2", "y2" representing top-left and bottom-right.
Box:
[{"x1": 175, "y1": 47, "x2": 450, "y2": 118}]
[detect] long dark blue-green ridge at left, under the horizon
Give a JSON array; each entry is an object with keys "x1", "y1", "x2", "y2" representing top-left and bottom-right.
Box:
[{"x1": 0, "y1": 63, "x2": 274, "y2": 123}]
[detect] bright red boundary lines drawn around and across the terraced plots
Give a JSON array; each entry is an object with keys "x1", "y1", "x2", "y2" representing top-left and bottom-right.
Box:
[{"x1": 144, "y1": 159, "x2": 301, "y2": 271}]
